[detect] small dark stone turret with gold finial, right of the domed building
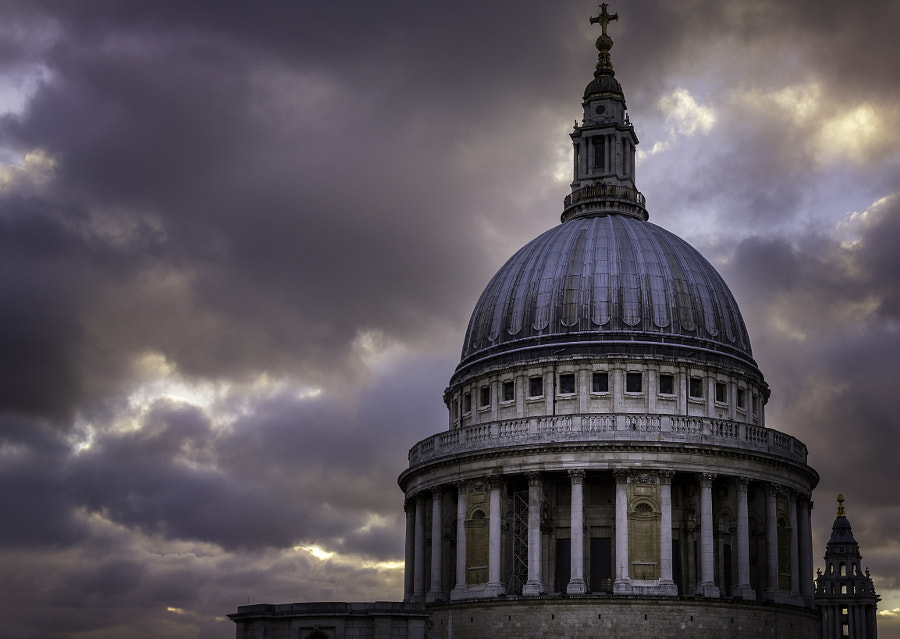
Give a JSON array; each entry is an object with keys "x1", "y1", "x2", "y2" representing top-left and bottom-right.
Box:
[{"x1": 816, "y1": 494, "x2": 880, "y2": 639}]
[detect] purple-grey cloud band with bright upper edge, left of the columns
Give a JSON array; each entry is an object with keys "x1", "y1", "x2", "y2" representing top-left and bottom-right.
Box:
[{"x1": 0, "y1": 356, "x2": 446, "y2": 559}]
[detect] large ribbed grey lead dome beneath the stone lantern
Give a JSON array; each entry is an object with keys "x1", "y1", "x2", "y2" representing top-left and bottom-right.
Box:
[{"x1": 457, "y1": 215, "x2": 756, "y2": 371}]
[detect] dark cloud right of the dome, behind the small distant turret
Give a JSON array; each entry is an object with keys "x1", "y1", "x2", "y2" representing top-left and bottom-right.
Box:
[{"x1": 726, "y1": 191, "x2": 900, "y2": 587}]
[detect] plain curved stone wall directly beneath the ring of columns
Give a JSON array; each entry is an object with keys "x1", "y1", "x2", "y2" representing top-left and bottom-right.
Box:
[{"x1": 426, "y1": 595, "x2": 819, "y2": 639}]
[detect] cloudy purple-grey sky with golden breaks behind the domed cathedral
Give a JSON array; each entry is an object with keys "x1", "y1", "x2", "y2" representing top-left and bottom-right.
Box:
[{"x1": 0, "y1": 0, "x2": 900, "y2": 639}]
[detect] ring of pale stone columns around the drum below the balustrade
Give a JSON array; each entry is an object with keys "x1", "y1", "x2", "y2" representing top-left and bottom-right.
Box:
[{"x1": 404, "y1": 469, "x2": 813, "y2": 606}]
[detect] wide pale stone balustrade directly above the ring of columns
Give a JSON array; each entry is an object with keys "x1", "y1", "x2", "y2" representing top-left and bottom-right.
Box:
[{"x1": 409, "y1": 413, "x2": 807, "y2": 466}]
